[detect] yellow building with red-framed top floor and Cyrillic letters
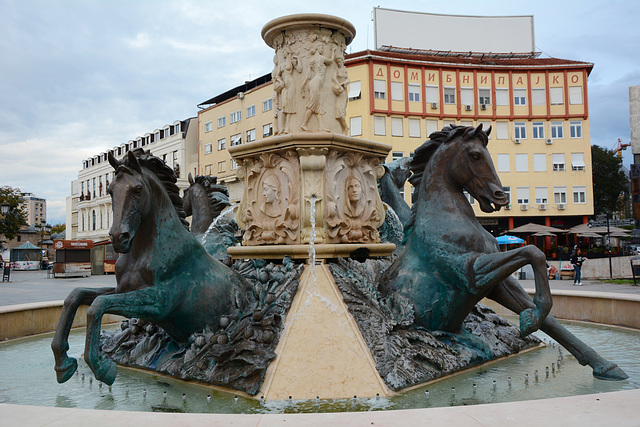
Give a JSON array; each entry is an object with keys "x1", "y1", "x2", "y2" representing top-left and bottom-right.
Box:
[{"x1": 198, "y1": 48, "x2": 593, "y2": 234}]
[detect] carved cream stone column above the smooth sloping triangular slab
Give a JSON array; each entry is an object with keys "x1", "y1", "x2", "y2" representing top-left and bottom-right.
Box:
[{"x1": 229, "y1": 14, "x2": 394, "y2": 258}]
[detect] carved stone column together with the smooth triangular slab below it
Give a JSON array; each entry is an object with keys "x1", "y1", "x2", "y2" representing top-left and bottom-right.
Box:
[{"x1": 228, "y1": 14, "x2": 395, "y2": 400}]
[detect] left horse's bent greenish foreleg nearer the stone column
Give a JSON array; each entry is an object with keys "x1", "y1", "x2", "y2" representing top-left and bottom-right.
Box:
[{"x1": 84, "y1": 287, "x2": 178, "y2": 385}]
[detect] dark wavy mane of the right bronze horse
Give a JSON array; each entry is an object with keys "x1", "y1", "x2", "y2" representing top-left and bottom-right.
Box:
[{"x1": 403, "y1": 124, "x2": 491, "y2": 244}]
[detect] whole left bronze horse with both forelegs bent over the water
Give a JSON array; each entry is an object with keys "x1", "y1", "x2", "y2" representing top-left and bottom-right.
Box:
[{"x1": 51, "y1": 149, "x2": 252, "y2": 385}]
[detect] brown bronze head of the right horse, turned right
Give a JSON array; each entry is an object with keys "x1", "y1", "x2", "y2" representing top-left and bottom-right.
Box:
[{"x1": 437, "y1": 124, "x2": 509, "y2": 213}]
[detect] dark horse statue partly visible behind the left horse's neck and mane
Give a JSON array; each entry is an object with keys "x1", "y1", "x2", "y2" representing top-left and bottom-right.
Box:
[{"x1": 182, "y1": 173, "x2": 231, "y2": 236}]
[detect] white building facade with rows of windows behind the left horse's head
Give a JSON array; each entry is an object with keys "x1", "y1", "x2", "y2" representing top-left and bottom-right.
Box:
[{"x1": 66, "y1": 117, "x2": 198, "y2": 242}]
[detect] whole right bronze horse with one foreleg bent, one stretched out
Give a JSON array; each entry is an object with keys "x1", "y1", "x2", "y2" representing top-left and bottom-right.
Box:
[{"x1": 380, "y1": 125, "x2": 627, "y2": 380}]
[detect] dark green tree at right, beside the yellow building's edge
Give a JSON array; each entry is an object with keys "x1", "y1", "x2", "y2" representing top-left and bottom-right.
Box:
[{"x1": 591, "y1": 145, "x2": 629, "y2": 214}]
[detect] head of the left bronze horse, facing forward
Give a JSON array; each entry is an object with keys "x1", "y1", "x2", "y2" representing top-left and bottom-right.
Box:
[{"x1": 107, "y1": 151, "x2": 152, "y2": 253}]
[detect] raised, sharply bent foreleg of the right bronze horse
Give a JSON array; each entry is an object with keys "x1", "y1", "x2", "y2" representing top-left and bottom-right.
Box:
[{"x1": 473, "y1": 246, "x2": 553, "y2": 337}]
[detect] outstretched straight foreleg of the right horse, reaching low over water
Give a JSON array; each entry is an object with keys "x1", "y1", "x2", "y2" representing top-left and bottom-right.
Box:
[{"x1": 488, "y1": 278, "x2": 628, "y2": 380}]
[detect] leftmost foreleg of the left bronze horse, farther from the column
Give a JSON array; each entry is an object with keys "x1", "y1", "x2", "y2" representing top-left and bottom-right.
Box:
[{"x1": 51, "y1": 288, "x2": 115, "y2": 383}]
